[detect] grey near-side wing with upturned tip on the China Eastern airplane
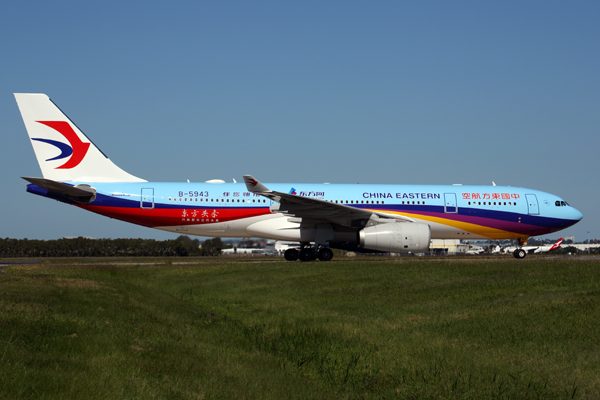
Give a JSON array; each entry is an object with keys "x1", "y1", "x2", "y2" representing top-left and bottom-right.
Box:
[{"x1": 244, "y1": 175, "x2": 414, "y2": 227}]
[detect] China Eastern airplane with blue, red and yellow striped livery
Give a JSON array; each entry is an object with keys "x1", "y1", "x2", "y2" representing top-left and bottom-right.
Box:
[{"x1": 15, "y1": 93, "x2": 582, "y2": 261}]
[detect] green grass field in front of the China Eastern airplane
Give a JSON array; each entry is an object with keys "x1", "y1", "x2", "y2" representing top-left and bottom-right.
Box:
[{"x1": 0, "y1": 257, "x2": 600, "y2": 399}]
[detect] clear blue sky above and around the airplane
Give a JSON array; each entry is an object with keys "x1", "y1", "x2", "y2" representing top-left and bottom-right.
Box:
[{"x1": 0, "y1": 1, "x2": 600, "y2": 240}]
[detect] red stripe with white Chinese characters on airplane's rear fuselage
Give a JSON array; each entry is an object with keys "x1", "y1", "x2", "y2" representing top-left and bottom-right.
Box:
[{"x1": 77, "y1": 205, "x2": 271, "y2": 228}]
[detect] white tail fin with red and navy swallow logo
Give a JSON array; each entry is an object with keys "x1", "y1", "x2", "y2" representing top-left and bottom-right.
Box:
[{"x1": 15, "y1": 93, "x2": 145, "y2": 182}]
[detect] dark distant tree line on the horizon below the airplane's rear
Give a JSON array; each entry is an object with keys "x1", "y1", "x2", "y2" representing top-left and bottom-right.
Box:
[{"x1": 0, "y1": 235, "x2": 223, "y2": 258}]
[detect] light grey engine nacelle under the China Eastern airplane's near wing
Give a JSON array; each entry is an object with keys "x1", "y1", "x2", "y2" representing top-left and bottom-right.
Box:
[{"x1": 359, "y1": 222, "x2": 431, "y2": 253}]
